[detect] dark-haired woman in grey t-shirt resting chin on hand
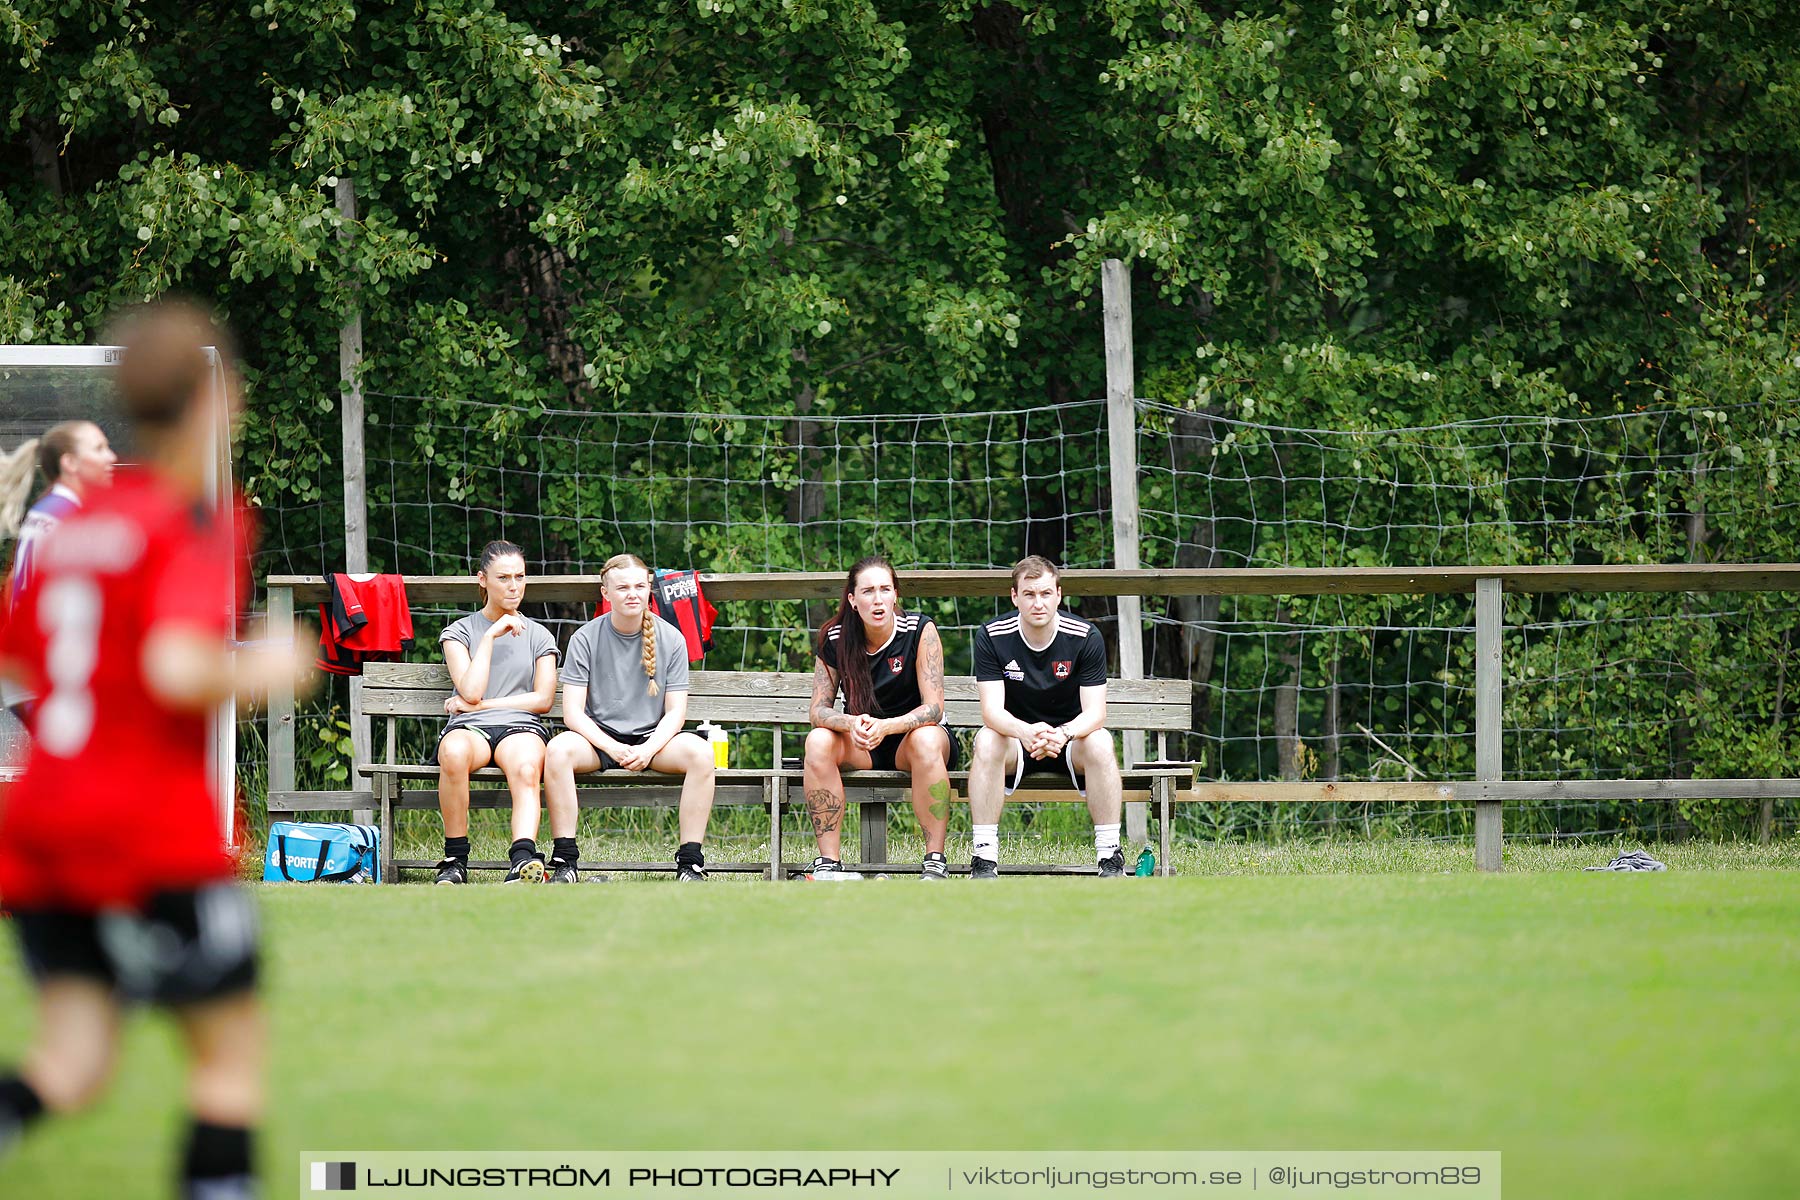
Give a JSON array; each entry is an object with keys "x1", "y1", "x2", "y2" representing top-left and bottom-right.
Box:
[{"x1": 434, "y1": 542, "x2": 554, "y2": 883}]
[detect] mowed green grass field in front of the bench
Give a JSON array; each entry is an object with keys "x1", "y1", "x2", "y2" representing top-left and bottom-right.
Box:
[{"x1": 0, "y1": 855, "x2": 1800, "y2": 1198}]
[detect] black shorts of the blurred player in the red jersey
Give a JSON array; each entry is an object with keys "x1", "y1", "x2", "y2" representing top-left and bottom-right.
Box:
[{"x1": 13, "y1": 883, "x2": 259, "y2": 1007}]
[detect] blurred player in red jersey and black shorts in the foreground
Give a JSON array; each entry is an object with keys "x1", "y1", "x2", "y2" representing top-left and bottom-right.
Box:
[{"x1": 0, "y1": 302, "x2": 304, "y2": 1200}]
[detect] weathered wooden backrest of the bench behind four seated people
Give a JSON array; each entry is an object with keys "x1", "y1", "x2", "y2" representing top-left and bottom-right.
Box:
[{"x1": 362, "y1": 662, "x2": 1193, "y2": 732}]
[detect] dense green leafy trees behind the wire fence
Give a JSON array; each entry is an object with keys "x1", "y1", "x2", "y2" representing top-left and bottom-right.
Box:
[{"x1": 0, "y1": 0, "x2": 1800, "y2": 820}]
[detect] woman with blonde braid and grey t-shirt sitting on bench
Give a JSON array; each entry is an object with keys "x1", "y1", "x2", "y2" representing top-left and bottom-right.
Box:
[{"x1": 544, "y1": 554, "x2": 713, "y2": 883}]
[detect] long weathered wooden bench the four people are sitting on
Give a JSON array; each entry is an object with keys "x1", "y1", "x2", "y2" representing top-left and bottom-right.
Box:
[{"x1": 268, "y1": 662, "x2": 1193, "y2": 882}]
